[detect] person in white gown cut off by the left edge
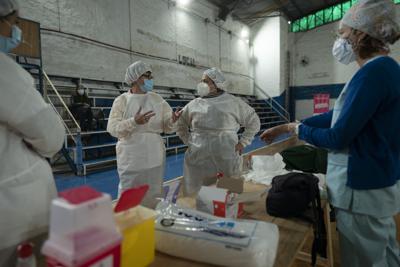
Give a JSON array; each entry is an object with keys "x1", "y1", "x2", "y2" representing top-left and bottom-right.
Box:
[{"x1": 0, "y1": 0, "x2": 64, "y2": 267}]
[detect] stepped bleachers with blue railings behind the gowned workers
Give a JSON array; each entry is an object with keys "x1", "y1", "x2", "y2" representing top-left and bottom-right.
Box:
[{"x1": 36, "y1": 77, "x2": 285, "y2": 174}]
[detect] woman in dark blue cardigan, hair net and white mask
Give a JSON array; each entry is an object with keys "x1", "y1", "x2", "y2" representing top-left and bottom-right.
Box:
[{"x1": 261, "y1": 0, "x2": 400, "y2": 267}]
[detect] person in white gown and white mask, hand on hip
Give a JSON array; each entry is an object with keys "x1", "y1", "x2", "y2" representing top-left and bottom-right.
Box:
[{"x1": 177, "y1": 68, "x2": 260, "y2": 196}]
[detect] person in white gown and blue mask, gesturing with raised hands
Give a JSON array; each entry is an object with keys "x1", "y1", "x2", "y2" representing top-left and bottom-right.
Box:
[{"x1": 107, "y1": 61, "x2": 180, "y2": 208}]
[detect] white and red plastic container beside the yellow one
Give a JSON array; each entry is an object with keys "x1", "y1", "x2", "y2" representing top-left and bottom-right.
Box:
[{"x1": 42, "y1": 186, "x2": 122, "y2": 267}]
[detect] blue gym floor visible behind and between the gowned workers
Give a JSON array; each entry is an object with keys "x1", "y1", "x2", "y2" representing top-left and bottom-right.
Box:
[{"x1": 55, "y1": 137, "x2": 265, "y2": 199}]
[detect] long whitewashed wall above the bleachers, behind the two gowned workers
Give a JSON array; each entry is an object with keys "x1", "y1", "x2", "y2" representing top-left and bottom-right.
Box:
[{"x1": 20, "y1": 0, "x2": 253, "y2": 94}]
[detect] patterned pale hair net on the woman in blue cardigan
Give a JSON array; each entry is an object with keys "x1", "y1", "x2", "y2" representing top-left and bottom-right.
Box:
[{"x1": 341, "y1": 0, "x2": 400, "y2": 44}]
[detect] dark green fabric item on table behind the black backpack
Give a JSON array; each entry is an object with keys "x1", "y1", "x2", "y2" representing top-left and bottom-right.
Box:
[{"x1": 281, "y1": 145, "x2": 328, "y2": 174}]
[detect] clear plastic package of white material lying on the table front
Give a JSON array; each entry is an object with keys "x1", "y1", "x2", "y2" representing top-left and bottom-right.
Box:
[{"x1": 156, "y1": 201, "x2": 279, "y2": 267}]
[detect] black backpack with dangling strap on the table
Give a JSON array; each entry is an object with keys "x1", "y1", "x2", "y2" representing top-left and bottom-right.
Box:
[{"x1": 266, "y1": 172, "x2": 327, "y2": 266}]
